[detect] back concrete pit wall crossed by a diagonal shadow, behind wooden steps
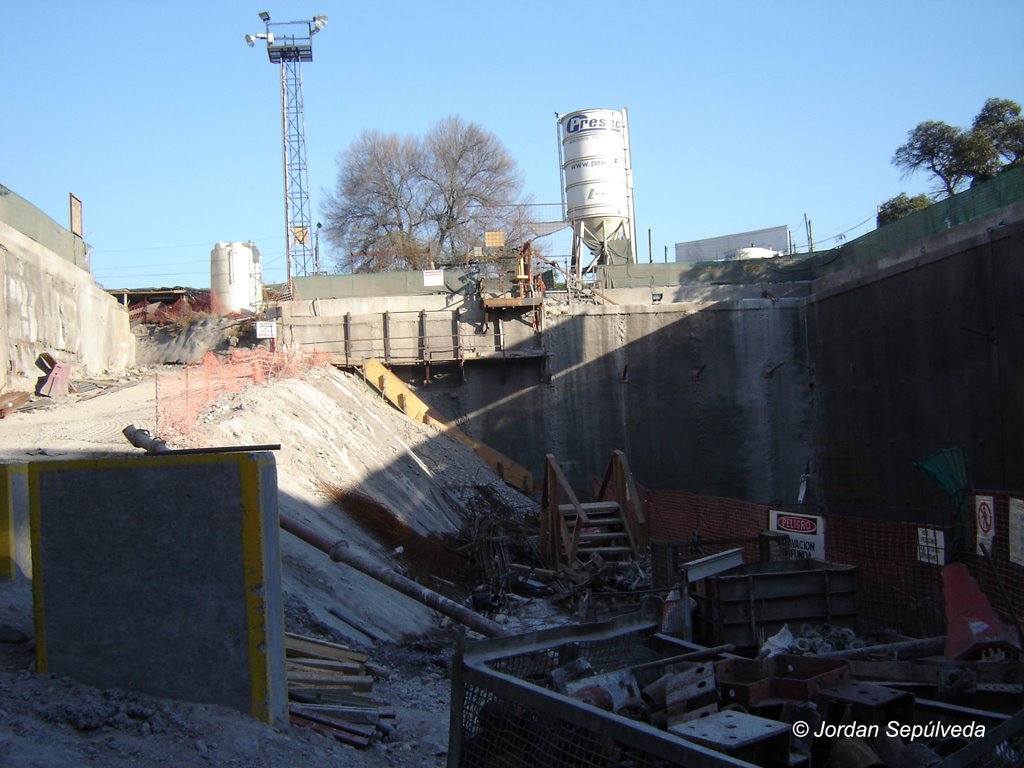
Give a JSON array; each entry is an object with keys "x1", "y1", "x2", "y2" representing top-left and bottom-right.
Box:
[{"x1": 421, "y1": 299, "x2": 810, "y2": 500}]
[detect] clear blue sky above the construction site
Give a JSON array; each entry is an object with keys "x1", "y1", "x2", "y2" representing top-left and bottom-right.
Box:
[{"x1": 0, "y1": 0, "x2": 1024, "y2": 289}]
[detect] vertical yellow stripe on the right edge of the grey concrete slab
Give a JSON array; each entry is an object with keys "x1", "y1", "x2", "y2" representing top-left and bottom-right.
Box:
[{"x1": 239, "y1": 455, "x2": 270, "y2": 723}]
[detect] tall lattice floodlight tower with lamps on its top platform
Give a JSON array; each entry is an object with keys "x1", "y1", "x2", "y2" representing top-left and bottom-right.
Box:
[{"x1": 246, "y1": 10, "x2": 327, "y2": 283}]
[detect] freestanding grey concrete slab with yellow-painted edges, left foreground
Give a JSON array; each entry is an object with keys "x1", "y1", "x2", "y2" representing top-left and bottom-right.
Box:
[{"x1": 29, "y1": 453, "x2": 287, "y2": 723}]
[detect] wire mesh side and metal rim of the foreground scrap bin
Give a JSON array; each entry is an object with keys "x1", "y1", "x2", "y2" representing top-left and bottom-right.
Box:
[{"x1": 447, "y1": 617, "x2": 754, "y2": 768}]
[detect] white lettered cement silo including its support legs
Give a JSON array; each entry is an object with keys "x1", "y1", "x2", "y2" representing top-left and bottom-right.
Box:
[{"x1": 556, "y1": 109, "x2": 636, "y2": 273}]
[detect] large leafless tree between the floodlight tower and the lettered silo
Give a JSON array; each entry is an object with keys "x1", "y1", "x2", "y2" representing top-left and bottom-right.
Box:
[{"x1": 324, "y1": 117, "x2": 524, "y2": 271}]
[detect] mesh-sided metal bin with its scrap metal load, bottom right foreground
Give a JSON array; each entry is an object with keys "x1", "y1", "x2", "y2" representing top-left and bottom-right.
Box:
[{"x1": 449, "y1": 616, "x2": 1024, "y2": 768}]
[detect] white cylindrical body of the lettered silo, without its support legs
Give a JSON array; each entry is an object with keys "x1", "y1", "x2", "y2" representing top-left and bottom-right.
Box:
[{"x1": 559, "y1": 110, "x2": 630, "y2": 229}]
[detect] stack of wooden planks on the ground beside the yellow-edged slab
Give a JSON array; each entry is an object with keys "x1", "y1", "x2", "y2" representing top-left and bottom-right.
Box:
[{"x1": 285, "y1": 633, "x2": 395, "y2": 749}]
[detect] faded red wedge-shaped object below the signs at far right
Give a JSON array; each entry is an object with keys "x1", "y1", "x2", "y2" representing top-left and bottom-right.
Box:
[{"x1": 942, "y1": 562, "x2": 1021, "y2": 660}]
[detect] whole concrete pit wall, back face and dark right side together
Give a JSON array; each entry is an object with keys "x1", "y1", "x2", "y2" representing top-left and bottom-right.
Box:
[{"x1": 411, "y1": 204, "x2": 1024, "y2": 521}]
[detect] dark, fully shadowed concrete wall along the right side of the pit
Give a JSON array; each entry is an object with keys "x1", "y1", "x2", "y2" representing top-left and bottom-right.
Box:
[{"x1": 807, "y1": 204, "x2": 1024, "y2": 519}]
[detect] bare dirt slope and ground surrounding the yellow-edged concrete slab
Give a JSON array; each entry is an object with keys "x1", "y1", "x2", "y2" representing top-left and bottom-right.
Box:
[{"x1": 0, "y1": 369, "x2": 532, "y2": 768}]
